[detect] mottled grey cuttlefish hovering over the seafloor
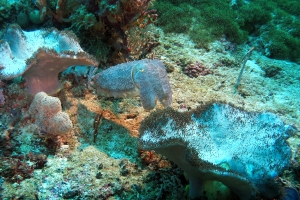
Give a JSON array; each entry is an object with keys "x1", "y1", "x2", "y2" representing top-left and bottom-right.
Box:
[{"x1": 94, "y1": 59, "x2": 172, "y2": 110}]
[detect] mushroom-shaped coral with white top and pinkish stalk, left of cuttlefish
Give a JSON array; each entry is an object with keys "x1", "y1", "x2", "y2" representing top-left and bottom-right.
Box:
[{"x1": 0, "y1": 25, "x2": 98, "y2": 95}]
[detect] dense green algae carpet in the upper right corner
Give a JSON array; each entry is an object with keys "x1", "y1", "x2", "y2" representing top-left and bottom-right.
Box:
[{"x1": 154, "y1": 0, "x2": 300, "y2": 62}]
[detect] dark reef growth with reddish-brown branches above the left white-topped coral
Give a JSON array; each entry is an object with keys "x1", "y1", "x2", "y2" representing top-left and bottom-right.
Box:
[{"x1": 0, "y1": 0, "x2": 158, "y2": 64}]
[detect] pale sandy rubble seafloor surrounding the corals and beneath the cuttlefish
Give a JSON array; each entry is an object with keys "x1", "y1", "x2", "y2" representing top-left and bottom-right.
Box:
[{"x1": 0, "y1": 9, "x2": 300, "y2": 199}]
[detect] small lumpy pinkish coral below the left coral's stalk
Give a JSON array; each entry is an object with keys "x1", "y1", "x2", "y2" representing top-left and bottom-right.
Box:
[{"x1": 29, "y1": 92, "x2": 73, "y2": 135}]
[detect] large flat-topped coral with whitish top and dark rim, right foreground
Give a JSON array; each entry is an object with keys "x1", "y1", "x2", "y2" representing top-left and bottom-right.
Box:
[{"x1": 139, "y1": 103, "x2": 297, "y2": 200}]
